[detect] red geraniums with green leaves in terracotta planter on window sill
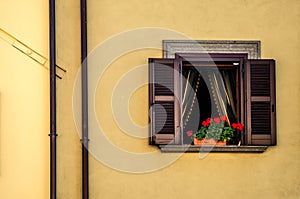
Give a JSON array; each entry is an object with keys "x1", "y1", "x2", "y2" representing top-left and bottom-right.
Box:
[{"x1": 187, "y1": 116, "x2": 244, "y2": 146}]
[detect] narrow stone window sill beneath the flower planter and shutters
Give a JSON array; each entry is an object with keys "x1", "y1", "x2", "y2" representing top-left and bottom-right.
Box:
[{"x1": 159, "y1": 145, "x2": 268, "y2": 153}]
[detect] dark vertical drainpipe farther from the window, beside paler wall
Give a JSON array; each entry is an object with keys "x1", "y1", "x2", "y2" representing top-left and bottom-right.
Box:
[{"x1": 49, "y1": 0, "x2": 57, "y2": 199}]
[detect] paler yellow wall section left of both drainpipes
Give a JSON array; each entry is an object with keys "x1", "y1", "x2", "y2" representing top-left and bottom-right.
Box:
[{"x1": 0, "y1": 0, "x2": 49, "y2": 199}]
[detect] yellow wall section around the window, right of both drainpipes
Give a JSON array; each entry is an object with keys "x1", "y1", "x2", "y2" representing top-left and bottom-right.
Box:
[{"x1": 88, "y1": 0, "x2": 300, "y2": 199}]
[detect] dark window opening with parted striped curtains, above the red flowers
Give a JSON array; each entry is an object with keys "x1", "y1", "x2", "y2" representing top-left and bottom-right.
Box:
[{"x1": 182, "y1": 65, "x2": 238, "y2": 143}]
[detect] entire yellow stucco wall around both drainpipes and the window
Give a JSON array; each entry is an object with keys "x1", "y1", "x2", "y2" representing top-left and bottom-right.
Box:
[{"x1": 0, "y1": 0, "x2": 300, "y2": 199}]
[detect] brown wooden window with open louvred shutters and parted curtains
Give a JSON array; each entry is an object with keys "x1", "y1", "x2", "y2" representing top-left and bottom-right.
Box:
[{"x1": 149, "y1": 53, "x2": 276, "y2": 145}]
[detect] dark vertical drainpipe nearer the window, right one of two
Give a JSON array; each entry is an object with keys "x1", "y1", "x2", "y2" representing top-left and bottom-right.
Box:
[{"x1": 81, "y1": 0, "x2": 89, "y2": 199}]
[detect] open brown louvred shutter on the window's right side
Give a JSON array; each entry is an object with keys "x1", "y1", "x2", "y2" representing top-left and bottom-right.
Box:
[{"x1": 245, "y1": 60, "x2": 276, "y2": 145}]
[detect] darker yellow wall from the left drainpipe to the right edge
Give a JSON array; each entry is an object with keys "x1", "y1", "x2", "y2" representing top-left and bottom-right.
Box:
[{"x1": 57, "y1": 0, "x2": 300, "y2": 199}]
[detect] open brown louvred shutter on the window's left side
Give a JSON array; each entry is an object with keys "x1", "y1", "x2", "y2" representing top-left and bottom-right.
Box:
[{"x1": 149, "y1": 58, "x2": 179, "y2": 144}]
